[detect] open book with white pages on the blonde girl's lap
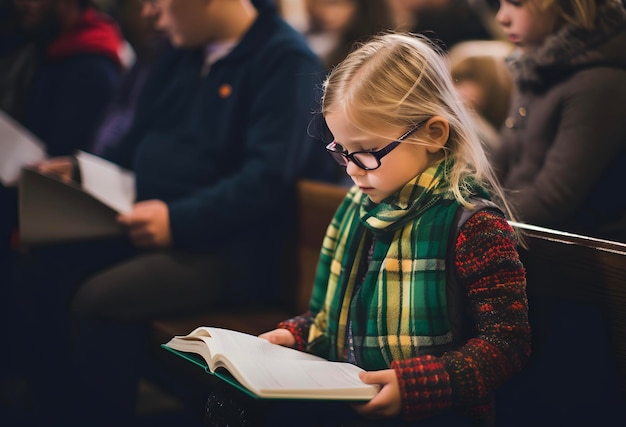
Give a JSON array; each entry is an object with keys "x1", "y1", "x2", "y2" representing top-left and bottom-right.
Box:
[{"x1": 161, "y1": 327, "x2": 378, "y2": 401}]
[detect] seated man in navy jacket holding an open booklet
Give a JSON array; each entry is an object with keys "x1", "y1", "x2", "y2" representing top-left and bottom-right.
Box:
[{"x1": 7, "y1": 0, "x2": 335, "y2": 426}]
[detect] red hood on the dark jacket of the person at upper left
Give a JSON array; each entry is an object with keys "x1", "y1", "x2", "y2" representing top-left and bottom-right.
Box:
[{"x1": 48, "y1": 9, "x2": 123, "y2": 66}]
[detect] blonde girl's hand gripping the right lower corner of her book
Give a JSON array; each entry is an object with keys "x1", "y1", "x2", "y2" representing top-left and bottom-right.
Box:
[{"x1": 353, "y1": 369, "x2": 402, "y2": 418}]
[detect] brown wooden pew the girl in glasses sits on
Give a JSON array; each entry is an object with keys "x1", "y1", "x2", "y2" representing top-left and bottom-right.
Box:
[{"x1": 147, "y1": 181, "x2": 626, "y2": 409}]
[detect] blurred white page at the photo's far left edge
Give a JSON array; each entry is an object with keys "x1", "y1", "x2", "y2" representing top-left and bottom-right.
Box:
[{"x1": 0, "y1": 110, "x2": 47, "y2": 187}]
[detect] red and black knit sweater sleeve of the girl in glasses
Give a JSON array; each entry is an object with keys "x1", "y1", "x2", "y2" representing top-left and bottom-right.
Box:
[{"x1": 391, "y1": 211, "x2": 530, "y2": 420}]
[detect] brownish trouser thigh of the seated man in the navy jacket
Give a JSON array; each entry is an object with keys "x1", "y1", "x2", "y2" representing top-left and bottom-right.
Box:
[{"x1": 72, "y1": 251, "x2": 228, "y2": 321}]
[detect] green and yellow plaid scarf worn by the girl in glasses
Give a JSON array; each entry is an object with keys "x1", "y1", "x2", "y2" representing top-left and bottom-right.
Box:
[{"x1": 308, "y1": 161, "x2": 485, "y2": 370}]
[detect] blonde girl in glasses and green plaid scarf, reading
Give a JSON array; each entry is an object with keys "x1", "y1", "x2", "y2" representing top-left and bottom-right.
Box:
[{"x1": 261, "y1": 34, "x2": 530, "y2": 425}]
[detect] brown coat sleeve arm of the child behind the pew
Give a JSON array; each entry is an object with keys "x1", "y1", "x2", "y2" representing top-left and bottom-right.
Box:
[{"x1": 500, "y1": 68, "x2": 626, "y2": 226}]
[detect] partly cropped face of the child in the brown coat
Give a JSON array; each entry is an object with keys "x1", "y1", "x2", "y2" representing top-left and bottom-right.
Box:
[{"x1": 496, "y1": 0, "x2": 558, "y2": 51}]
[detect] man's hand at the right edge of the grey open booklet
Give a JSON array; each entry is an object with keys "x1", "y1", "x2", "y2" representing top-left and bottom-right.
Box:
[{"x1": 118, "y1": 200, "x2": 172, "y2": 249}]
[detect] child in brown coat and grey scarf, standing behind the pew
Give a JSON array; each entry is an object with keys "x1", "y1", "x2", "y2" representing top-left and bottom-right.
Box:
[{"x1": 493, "y1": 0, "x2": 626, "y2": 241}]
